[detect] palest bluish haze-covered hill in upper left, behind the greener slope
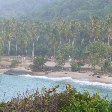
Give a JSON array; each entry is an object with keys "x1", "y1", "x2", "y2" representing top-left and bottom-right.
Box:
[{"x1": 0, "y1": 0, "x2": 50, "y2": 18}]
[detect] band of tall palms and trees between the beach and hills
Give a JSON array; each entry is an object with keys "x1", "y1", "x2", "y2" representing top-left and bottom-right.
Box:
[{"x1": 0, "y1": 17, "x2": 112, "y2": 70}]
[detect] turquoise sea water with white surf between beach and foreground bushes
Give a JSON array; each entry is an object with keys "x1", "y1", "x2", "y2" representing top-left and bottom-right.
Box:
[{"x1": 0, "y1": 74, "x2": 112, "y2": 102}]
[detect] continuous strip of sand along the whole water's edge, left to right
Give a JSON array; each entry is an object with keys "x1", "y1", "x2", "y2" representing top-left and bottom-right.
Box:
[{"x1": 0, "y1": 67, "x2": 112, "y2": 84}]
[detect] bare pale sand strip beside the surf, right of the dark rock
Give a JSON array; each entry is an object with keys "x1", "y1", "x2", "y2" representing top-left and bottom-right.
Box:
[{"x1": 46, "y1": 72, "x2": 112, "y2": 84}]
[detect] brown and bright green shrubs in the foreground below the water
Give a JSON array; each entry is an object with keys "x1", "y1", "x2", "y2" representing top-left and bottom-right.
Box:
[{"x1": 0, "y1": 85, "x2": 112, "y2": 112}]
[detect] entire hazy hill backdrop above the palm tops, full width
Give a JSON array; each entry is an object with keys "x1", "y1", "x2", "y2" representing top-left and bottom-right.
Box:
[{"x1": 0, "y1": 0, "x2": 112, "y2": 20}]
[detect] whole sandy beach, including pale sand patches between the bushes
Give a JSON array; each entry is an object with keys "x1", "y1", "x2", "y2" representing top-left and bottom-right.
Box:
[{"x1": 0, "y1": 58, "x2": 112, "y2": 84}]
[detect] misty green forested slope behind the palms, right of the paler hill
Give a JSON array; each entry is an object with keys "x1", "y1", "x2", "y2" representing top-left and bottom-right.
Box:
[{"x1": 33, "y1": 0, "x2": 112, "y2": 20}]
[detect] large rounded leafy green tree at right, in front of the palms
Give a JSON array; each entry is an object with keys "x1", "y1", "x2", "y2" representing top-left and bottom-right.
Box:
[{"x1": 87, "y1": 41, "x2": 112, "y2": 68}]
